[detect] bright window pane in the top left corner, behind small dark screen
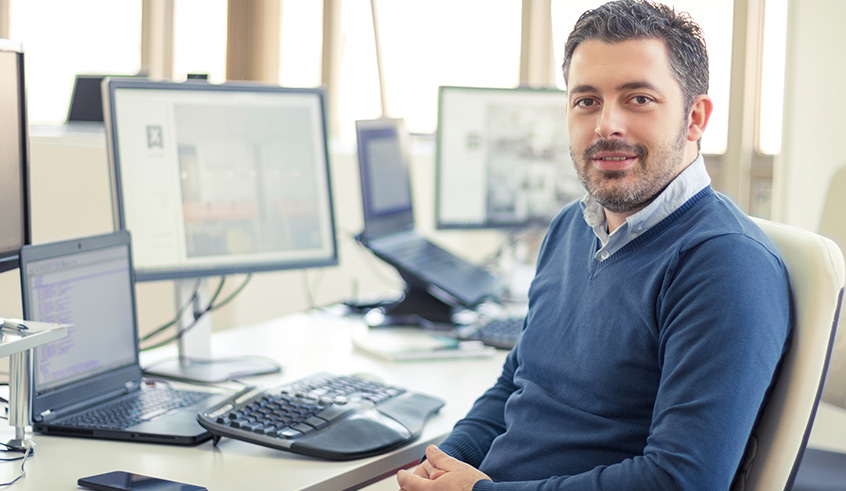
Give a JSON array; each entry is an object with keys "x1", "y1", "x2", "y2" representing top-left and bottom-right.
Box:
[{"x1": 9, "y1": 0, "x2": 141, "y2": 124}]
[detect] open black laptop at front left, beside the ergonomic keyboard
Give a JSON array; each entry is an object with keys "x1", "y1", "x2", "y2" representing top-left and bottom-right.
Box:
[{"x1": 20, "y1": 231, "x2": 223, "y2": 445}]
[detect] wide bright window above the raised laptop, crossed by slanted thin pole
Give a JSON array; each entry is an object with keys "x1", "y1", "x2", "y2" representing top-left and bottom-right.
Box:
[{"x1": 338, "y1": 0, "x2": 522, "y2": 139}]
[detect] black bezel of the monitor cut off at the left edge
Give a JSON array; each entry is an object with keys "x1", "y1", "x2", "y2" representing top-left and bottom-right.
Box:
[{"x1": 0, "y1": 39, "x2": 32, "y2": 273}]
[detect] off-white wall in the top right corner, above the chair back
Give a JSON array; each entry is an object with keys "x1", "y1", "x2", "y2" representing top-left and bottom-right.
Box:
[{"x1": 774, "y1": 0, "x2": 846, "y2": 234}]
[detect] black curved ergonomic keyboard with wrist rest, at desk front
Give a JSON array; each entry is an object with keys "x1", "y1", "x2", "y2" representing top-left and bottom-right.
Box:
[{"x1": 197, "y1": 373, "x2": 444, "y2": 460}]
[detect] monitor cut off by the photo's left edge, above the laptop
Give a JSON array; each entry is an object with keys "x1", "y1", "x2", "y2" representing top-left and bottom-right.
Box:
[{"x1": 0, "y1": 39, "x2": 30, "y2": 272}]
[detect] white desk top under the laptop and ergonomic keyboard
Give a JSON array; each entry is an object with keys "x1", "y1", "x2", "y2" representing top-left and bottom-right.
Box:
[{"x1": 0, "y1": 313, "x2": 505, "y2": 491}]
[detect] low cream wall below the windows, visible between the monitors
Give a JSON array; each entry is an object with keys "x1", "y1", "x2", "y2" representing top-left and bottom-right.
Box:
[{"x1": 0, "y1": 127, "x2": 510, "y2": 338}]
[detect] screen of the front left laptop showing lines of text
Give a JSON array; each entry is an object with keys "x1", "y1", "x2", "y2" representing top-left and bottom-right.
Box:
[{"x1": 23, "y1": 240, "x2": 137, "y2": 394}]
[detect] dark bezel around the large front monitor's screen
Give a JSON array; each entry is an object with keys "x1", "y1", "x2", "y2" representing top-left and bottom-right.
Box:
[{"x1": 102, "y1": 77, "x2": 339, "y2": 281}]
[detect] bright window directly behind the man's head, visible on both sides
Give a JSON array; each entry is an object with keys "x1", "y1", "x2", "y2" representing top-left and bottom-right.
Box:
[{"x1": 552, "y1": 0, "x2": 734, "y2": 154}]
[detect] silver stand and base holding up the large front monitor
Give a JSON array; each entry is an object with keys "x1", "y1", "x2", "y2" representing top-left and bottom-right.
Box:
[{"x1": 144, "y1": 280, "x2": 281, "y2": 384}]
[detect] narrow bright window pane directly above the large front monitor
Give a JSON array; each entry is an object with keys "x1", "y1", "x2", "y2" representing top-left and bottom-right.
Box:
[{"x1": 173, "y1": 0, "x2": 227, "y2": 83}]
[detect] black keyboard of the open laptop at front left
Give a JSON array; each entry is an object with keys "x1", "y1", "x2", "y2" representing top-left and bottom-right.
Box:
[{"x1": 59, "y1": 388, "x2": 212, "y2": 430}]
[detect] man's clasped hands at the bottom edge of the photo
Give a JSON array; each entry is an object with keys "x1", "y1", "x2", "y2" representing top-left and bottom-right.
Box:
[{"x1": 397, "y1": 445, "x2": 490, "y2": 491}]
